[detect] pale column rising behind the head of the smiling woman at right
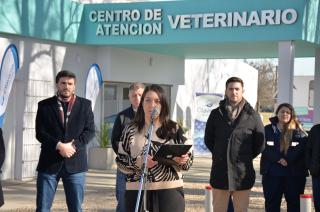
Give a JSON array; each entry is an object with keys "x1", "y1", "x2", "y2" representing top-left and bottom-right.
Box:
[{"x1": 277, "y1": 41, "x2": 295, "y2": 104}]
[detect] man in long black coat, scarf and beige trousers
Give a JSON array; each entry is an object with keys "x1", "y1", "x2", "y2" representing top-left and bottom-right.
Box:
[{"x1": 204, "y1": 77, "x2": 265, "y2": 211}]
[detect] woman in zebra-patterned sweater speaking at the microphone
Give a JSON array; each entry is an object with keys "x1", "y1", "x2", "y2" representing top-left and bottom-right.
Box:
[{"x1": 116, "y1": 85, "x2": 193, "y2": 212}]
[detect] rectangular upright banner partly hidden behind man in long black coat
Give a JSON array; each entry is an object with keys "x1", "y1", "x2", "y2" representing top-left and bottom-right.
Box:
[{"x1": 193, "y1": 93, "x2": 223, "y2": 156}]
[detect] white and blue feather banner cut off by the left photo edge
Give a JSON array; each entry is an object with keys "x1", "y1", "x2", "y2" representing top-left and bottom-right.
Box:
[{"x1": 0, "y1": 44, "x2": 19, "y2": 128}]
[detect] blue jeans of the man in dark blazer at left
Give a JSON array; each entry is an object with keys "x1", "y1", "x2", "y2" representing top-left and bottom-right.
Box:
[{"x1": 36, "y1": 168, "x2": 85, "y2": 212}]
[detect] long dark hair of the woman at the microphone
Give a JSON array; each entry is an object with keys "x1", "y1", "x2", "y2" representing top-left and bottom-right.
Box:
[{"x1": 133, "y1": 84, "x2": 175, "y2": 138}]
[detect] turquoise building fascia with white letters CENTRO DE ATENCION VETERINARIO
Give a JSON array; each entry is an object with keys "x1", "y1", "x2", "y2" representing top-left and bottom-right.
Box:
[{"x1": 0, "y1": 0, "x2": 319, "y2": 46}]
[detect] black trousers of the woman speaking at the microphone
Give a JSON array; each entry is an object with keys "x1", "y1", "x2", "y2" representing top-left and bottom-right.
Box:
[{"x1": 125, "y1": 187, "x2": 185, "y2": 212}]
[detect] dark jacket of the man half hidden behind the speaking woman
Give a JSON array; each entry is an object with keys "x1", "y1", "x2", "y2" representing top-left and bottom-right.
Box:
[{"x1": 111, "y1": 106, "x2": 135, "y2": 154}]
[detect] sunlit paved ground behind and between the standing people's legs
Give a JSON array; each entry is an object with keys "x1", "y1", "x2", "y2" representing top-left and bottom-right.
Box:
[{"x1": 0, "y1": 158, "x2": 316, "y2": 212}]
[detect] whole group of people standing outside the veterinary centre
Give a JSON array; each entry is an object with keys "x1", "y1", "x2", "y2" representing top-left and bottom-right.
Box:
[{"x1": 0, "y1": 71, "x2": 320, "y2": 212}]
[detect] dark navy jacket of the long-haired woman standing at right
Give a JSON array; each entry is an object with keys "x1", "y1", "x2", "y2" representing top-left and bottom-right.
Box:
[{"x1": 260, "y1": 117, "x2": 308, "y2": 176}]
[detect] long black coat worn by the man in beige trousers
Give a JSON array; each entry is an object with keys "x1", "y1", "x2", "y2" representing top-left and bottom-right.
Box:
[{"x1": 204, "y1": 100, "x2": 265, "y2": 190}]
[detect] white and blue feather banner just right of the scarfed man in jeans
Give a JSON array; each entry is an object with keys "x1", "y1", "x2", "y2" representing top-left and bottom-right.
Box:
[{"x1": 84, "y1": 64, "x2": 103, "y2": 110}]
